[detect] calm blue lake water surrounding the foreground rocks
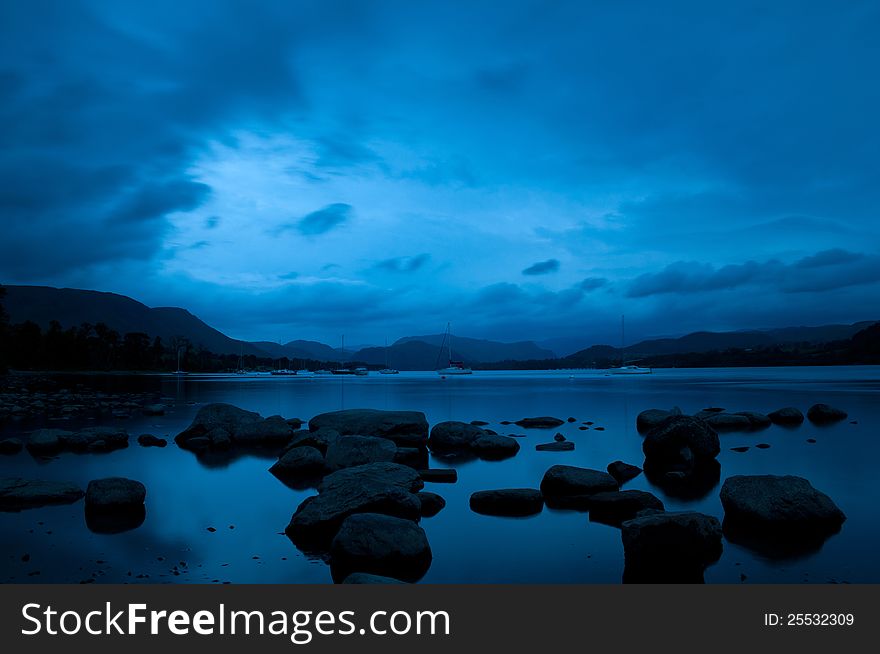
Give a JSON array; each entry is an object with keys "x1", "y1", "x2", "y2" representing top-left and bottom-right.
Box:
[{"x1": 0, "y1": 366, "x2": 880, "y2": 583}]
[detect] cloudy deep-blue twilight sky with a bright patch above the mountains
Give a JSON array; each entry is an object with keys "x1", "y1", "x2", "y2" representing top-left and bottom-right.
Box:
[{"x1": 0, "y1": 0, "x2": 880, "y2": 344}]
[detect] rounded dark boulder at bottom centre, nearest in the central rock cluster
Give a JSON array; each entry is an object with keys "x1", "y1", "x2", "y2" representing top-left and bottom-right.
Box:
[{"x1": 330, "y1": 513, "x2": 432, "y2": 581}]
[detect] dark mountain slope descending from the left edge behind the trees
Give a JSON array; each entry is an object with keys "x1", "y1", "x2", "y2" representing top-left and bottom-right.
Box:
[{"x1": 3, "y1": 285, "x2": 266, "y2": 356}]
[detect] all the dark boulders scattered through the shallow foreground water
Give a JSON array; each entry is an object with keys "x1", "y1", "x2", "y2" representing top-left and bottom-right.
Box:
[{"x1": 0, "y1": 391, "x2": 847, "y2": 583}]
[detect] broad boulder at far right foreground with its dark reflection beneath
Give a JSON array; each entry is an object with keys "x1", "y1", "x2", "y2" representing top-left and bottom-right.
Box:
[{"x1": 721, "y1": 475, "x2": 846, "y2": 556}]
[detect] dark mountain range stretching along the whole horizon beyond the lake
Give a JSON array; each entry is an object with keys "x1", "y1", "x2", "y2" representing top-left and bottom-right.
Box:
[{"x1": 3, "y1": 286, "x2": 874, "y2": 370}]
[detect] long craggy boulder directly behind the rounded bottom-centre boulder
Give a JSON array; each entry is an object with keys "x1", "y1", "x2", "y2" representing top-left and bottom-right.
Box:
[{"x1": 286, "y1": 463, "x2": 422, "y2": 550}]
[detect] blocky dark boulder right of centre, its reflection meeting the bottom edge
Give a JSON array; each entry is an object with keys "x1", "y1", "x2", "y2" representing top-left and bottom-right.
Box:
[{"x1": 621, "y1": 512, "x2": 722, "y2": 583}]
